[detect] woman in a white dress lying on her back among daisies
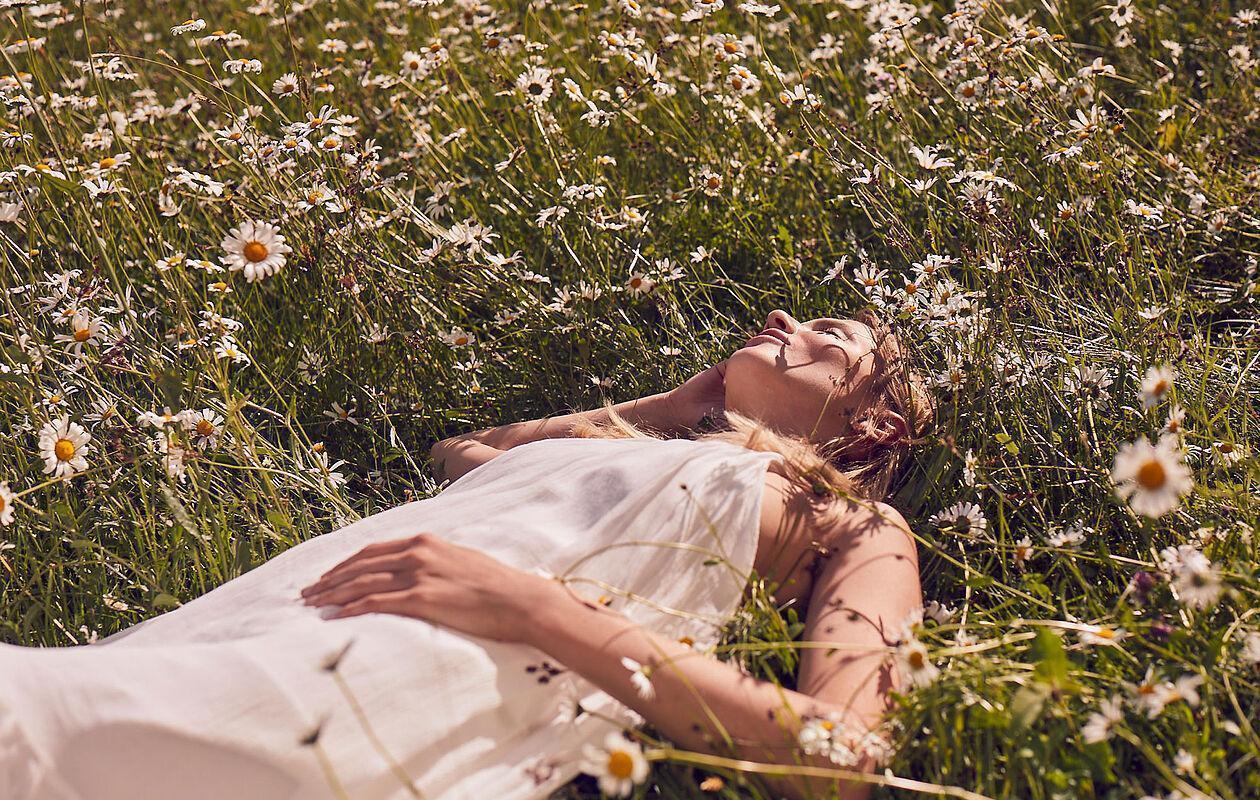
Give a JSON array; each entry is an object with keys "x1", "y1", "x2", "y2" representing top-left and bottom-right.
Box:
[{"x1": 0, "y1": 310, "x2": 931, "y2": 800}]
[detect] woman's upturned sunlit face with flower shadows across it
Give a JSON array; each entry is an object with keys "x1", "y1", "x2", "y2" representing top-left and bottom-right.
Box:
[{"x1": 726, "y1": 309, "x2": 878, "y2": 441}]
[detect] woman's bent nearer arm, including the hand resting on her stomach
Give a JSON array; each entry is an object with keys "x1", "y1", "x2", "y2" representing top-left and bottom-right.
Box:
[{"x1": 302, "y1": 506, "x2": 922, "y2": 800}]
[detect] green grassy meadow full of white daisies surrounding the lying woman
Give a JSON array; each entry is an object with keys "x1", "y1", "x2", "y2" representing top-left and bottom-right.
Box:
[{"x1": 0, "y1": 0, "x2": 1260, "y2": 800}]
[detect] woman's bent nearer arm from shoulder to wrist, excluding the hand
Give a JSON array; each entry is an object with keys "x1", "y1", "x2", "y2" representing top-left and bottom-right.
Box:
[{"x1": 516, "y1": 506, "x2": 922, "y2": 800}]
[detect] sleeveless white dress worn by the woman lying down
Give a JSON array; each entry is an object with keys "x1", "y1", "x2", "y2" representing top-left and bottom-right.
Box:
[{"x1": 0, "y1": 438, "x2": 779, "y2": 800}]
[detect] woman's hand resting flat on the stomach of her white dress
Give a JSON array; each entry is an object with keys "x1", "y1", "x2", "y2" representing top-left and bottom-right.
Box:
[{"x1": 301, "y1": 533, "x2": 563, "y2": 643}]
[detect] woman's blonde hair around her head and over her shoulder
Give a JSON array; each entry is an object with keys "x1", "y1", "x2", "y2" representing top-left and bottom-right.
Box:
[{"x1": 571, "y1": 309, "x2": 936, "y2": 519}]
